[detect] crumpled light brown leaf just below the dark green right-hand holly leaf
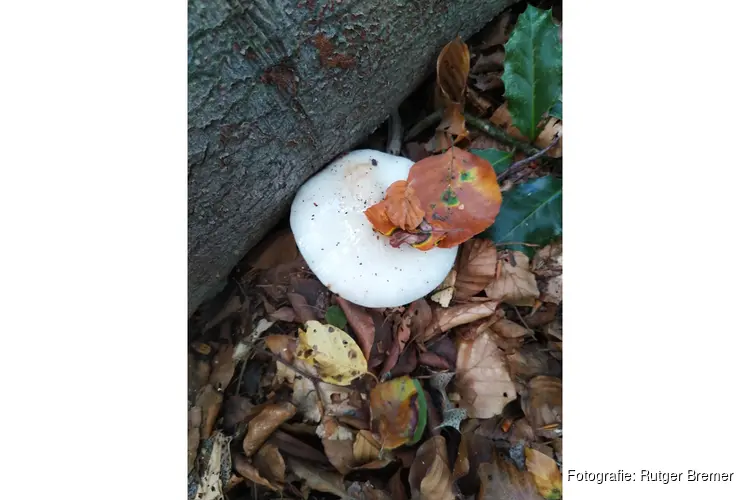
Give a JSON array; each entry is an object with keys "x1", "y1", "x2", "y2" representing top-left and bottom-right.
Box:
[{"x1": 484, "y1": 251, "x2": 539, "y2": 306}]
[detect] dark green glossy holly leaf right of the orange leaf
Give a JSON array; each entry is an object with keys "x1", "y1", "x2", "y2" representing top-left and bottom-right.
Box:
[{"x1": 483, "y1": 175, "x2": 562, "y2": 255}]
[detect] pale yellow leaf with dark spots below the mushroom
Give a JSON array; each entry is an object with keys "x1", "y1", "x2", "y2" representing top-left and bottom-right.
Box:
[{"x1": 297, "y1": 321, "x2": 367, "y2": 385}]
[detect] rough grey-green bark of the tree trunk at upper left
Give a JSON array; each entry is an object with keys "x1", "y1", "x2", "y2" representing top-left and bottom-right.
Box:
[{"x1": 188, "y1": 0, "x2": 514, "y2": 313}]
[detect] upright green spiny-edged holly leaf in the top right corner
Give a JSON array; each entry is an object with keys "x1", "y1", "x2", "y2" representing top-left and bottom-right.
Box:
[{"x1": 502, "y1": 5, "x2": 562, "y2": 142}]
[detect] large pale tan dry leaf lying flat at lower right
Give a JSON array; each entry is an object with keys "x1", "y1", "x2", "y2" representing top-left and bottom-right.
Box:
[{"x1": 456, "y1": 332, "x2": 516, "y2": 418}]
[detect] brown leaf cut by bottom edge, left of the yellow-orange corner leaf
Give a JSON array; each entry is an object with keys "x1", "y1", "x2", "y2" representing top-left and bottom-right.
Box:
[{"x1": 477, "y1": 456, "x2": 542, "y2": 500}]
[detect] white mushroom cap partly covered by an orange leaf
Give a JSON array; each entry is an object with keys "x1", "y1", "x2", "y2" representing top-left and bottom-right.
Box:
[{"x1": 290, "y1": 150, "x2": 458, "y2": 307}]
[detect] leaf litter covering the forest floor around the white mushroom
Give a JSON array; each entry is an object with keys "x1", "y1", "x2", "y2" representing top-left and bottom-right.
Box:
[{"x1": 188, "y1": 4, "x2": 563, "y2": 500}]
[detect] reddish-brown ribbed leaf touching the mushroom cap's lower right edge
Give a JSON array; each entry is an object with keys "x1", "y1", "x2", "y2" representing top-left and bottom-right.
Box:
[{"x1": 455, "y1": 238, "x2": 497, "y2": 300}]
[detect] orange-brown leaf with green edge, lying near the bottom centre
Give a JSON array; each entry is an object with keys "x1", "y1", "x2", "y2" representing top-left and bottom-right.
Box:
[{"x1": 370, "y1": 377, "x2": 427, "y2": 450}]
